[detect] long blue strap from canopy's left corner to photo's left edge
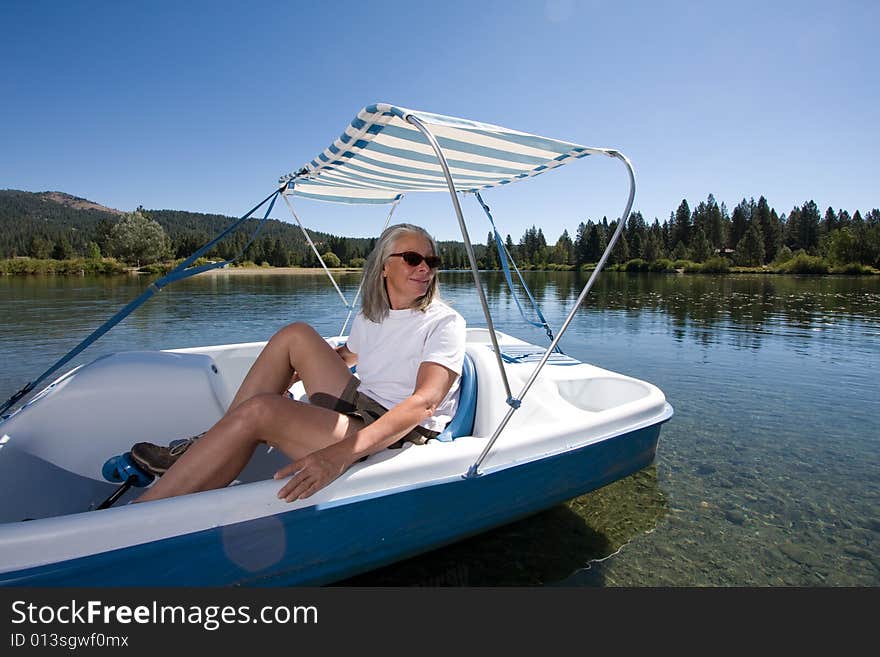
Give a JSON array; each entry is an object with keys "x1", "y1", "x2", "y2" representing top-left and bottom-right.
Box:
[{"x1": 0, "y1": 189, "x2": 281, "y2": 414}]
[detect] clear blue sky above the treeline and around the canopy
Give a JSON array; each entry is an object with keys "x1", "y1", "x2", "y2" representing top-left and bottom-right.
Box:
[{"x1": 0, "y1": 0, "x2": 880, "y2": 243}]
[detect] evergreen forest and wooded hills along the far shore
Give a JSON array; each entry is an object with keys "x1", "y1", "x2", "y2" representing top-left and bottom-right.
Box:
[{"x1": 0, "y1": 190, "x2": 880, "y2": 273}]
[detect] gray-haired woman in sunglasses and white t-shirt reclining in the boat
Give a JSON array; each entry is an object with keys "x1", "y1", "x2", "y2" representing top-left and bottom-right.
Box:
[{"x1": 133, "y1": 224, "x2": 465, "y2": 502}]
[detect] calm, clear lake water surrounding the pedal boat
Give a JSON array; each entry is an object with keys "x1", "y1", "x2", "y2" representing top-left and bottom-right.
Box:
[{"x1": 0, "y1": 272, "x2": 880, "y2": 586}]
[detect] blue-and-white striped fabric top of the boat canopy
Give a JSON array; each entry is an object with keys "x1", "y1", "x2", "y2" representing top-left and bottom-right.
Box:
[{"x1": 282, "y1": 104, "x2": 608, "y2": 203}]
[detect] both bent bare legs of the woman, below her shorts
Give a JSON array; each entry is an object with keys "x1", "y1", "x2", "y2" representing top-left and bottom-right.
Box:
[{"x1": 137, "y1": 323, "x2": 362, "y2": 502}]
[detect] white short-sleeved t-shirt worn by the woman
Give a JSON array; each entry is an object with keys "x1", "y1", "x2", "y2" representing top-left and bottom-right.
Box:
[{"x1": 346, "y1": 300, "x2": 466, "y2": 431}]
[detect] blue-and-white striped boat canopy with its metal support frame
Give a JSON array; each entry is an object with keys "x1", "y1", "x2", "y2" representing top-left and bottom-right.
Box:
[{"x1": 278, "y1": 103, "x2": 635, "y2": 477}]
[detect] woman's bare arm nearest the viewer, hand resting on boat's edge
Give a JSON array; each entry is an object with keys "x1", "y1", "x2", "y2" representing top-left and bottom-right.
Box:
[{"x1": 275, "y1": 362, "x2": 458, "y2": 502}]
